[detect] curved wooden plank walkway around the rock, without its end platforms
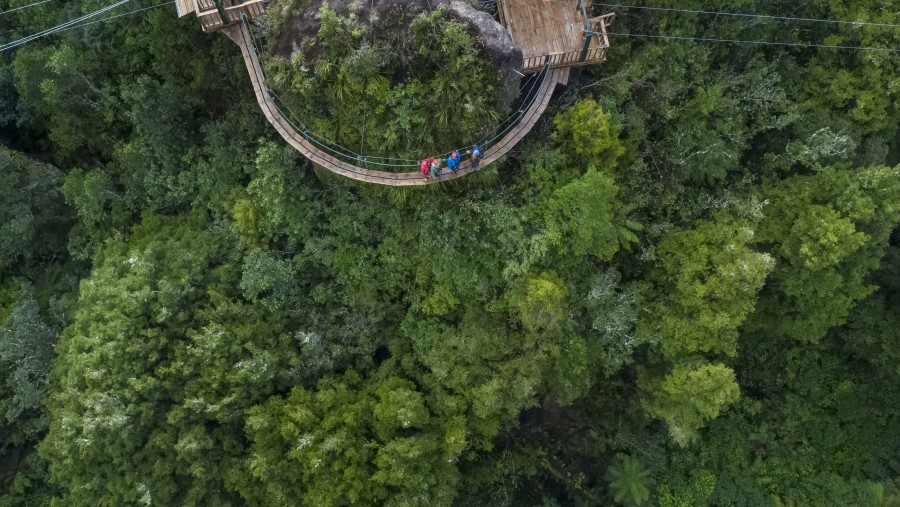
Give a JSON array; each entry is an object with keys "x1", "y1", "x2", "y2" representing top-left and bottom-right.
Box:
[{"x1": 222, "y1": 23, "x2": 569, "y2": 187}]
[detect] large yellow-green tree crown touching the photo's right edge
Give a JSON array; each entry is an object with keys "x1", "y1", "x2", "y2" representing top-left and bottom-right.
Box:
[{"x1": 756, "y1": 166, "x2": 900, "y2": 341}]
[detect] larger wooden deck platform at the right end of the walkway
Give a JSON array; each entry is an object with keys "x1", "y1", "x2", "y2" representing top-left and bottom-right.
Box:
[{"x1": 497, "y1": 0, "x2": 612, "y2": 72}]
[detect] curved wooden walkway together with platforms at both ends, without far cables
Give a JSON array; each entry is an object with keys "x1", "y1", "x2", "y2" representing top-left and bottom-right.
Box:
[{"x1": 176, "y1": 0, "x2": 613, "y2": 186}]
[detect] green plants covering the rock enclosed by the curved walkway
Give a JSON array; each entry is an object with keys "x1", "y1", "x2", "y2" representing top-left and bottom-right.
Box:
[{"x1": 264, "y1": 3, "x2": 509, "y2": 161}]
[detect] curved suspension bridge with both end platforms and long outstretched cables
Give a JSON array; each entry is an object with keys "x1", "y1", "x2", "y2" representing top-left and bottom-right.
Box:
[{"x1": 0, "y1": 0, "x2": 900, "y2": 186}]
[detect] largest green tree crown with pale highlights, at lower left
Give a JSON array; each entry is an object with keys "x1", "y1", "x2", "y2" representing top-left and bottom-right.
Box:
[{"x1": 41, "y1": 215, "x2": 297, "y2": 504}]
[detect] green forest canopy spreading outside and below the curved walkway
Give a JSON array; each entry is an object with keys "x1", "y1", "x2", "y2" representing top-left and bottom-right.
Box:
[{"x1": 0, "y1": 0, "x2": 900, "y2": 507}]
